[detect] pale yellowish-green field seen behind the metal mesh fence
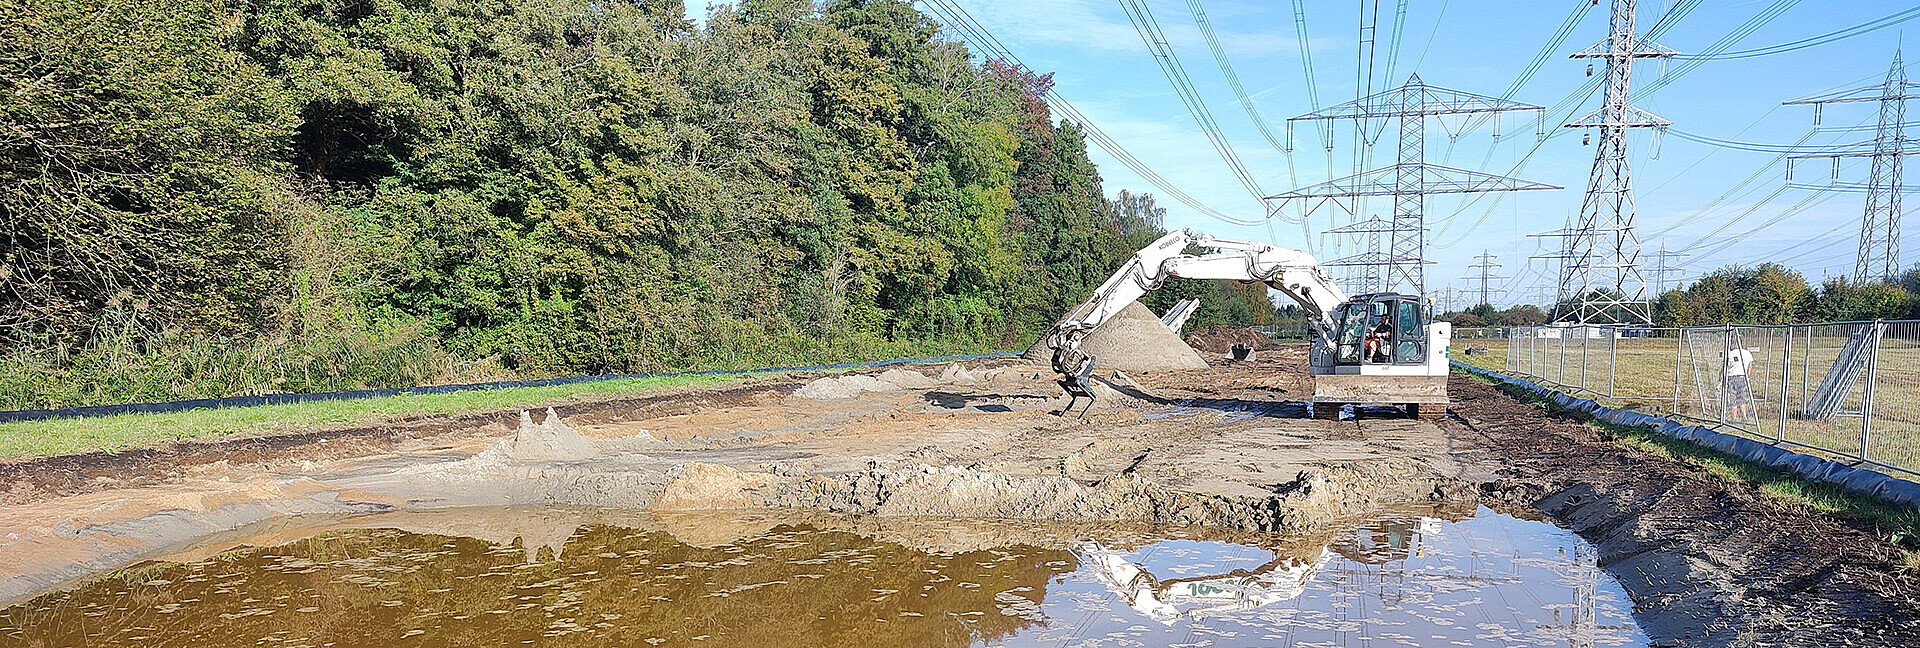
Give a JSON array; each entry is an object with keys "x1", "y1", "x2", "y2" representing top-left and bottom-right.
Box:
[{"x1": 1453, "y1": 336, "x2": 1920, "y2": 470}]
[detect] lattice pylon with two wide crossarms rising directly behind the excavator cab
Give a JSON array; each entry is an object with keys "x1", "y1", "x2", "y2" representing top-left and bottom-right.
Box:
[{"x1": 1267, "y1": 75, "x2": 1559, "y2": 295}]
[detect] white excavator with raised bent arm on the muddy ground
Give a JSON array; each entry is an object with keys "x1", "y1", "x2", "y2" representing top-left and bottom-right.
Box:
[{"x1": 1046, "y1": 230, "x2": 1453, "y2": 420}]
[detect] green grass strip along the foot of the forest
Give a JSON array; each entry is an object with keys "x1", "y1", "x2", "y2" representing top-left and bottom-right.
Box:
[{"x1": 0, "y1": 376, "x2": 745, "y2": 458}]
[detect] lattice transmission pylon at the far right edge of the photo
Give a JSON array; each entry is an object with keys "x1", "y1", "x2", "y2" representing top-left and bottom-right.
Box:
[{"x1": 1786, "y1": 50, "x2": 1920, "y2": 282}]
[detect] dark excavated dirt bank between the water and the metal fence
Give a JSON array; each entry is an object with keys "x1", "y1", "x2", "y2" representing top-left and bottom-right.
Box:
[{"x1": 1448, "y1": 374, "x2": 1920, "y2": 646}]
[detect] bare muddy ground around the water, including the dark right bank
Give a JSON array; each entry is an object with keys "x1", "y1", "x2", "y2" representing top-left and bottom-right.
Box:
[{"x1": 0, "y1": 347, "x2": 1920, "y2": 646}]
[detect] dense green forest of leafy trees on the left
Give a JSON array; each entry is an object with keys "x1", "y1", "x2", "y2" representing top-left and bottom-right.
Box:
[{"x1": 0, "y1": 0, "x2": 1271, "y2": 408}]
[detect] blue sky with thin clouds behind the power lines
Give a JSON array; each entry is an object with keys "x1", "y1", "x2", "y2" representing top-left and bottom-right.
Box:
[{"x1": 698, "y1": 0, "x2": 1920, "y2": 303}]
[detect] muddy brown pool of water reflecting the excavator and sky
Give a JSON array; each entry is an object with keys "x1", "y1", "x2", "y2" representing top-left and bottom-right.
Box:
[{"x1": 0, "y1": 508, "x2": 1645, "y2": 648}]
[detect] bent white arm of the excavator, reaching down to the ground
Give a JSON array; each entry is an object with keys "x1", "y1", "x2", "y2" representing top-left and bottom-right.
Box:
[{"x1": 1046, "y1": 230, "x2": 1348, "y2": 408}]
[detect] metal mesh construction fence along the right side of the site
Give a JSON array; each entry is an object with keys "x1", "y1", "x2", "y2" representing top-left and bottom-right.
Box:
[{"x1": 1455, "y1": 320, "x2": 1920, "y2": 475}]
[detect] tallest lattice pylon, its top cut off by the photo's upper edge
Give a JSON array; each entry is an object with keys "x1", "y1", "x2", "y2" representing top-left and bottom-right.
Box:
[{"x1": 1544, "y1": 0, "x2": 1678, "y2": 324}]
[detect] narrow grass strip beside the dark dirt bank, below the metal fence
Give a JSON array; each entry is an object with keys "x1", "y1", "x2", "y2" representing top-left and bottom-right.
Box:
[{"x1": 1467, "y1": 374, "x2": 1920, "y2": 571}]
